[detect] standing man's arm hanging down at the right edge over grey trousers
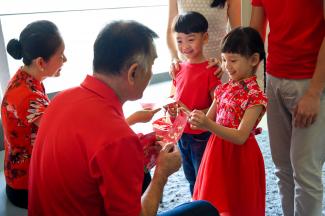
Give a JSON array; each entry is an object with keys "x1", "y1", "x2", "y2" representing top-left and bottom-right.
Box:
[{"x1": 295, "y1": 0, "x2": 325, "y2": 127}]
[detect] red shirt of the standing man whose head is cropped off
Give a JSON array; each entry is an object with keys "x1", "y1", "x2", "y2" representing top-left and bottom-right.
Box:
[{"x1": 252, "y1": 0, "x2": 325, "y2": 79}]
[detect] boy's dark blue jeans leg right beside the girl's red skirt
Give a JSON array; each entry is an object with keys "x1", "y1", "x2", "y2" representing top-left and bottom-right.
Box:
[{"x1": 191, "y1": 132, "x2": 211, "y2": 176}]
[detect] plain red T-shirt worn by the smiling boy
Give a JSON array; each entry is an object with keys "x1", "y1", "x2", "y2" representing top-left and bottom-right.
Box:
[{"x1": 174, "y1": 62, "x2": 221, "y2": 134}]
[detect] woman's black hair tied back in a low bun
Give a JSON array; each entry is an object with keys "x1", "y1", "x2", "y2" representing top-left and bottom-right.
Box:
[{"x1": 7, "y1": 20, "x2": 63, "y2": 65}]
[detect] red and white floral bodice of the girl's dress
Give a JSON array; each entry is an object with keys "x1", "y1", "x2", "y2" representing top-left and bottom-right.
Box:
[{"x1": 215, "y1": 76, "x2": 267, "y2": 128}]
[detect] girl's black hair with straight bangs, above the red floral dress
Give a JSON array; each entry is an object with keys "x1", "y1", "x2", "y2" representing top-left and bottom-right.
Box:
[{"x1": 221, "y1": 27, "x2": 266, "y2": 88}]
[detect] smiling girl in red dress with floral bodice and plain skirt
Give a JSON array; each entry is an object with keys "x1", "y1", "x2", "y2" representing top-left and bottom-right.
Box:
[{"x1": 190, "y1": 27, "x2": 267, "y2": 216}]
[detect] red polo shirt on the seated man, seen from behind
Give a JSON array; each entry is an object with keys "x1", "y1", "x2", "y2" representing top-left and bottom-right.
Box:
[{"x1": 28, "y1": 76, "x2": 144, "y2": 216}]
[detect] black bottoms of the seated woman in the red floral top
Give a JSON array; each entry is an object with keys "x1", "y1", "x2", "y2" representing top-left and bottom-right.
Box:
[{"x1": 6, "y1": 185, "x2": 28, "y2": 209}]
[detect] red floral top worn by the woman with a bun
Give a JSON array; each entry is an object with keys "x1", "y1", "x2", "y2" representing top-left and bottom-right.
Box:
[{"x1": 1, "y1": 69, "x2": 49, "y2": 190}]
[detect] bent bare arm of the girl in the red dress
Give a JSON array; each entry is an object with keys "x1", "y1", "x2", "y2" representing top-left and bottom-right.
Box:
[{"x1": 190, "y1": 105, "x2": 264, "y2": 145}]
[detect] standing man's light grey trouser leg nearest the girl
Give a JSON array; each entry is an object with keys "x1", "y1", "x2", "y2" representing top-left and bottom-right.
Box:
[{"x1": 267, "y1": 76, "x2": 295, "y2": 216}]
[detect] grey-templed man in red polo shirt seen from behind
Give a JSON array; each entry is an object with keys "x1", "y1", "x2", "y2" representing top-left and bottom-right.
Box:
[{"x1": 28, "y1": 21, "x2": 218, "y2": 216}]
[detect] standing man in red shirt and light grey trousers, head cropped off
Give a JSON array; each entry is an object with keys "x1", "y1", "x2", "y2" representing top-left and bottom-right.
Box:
[{"x1": 251, "y1": 0, "x2": 325, "y2": 216}]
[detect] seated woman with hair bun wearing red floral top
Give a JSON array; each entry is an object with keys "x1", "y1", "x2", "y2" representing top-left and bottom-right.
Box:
[{"x1": 1, "y1": 20, "x2": 66, "y2": 208}]
